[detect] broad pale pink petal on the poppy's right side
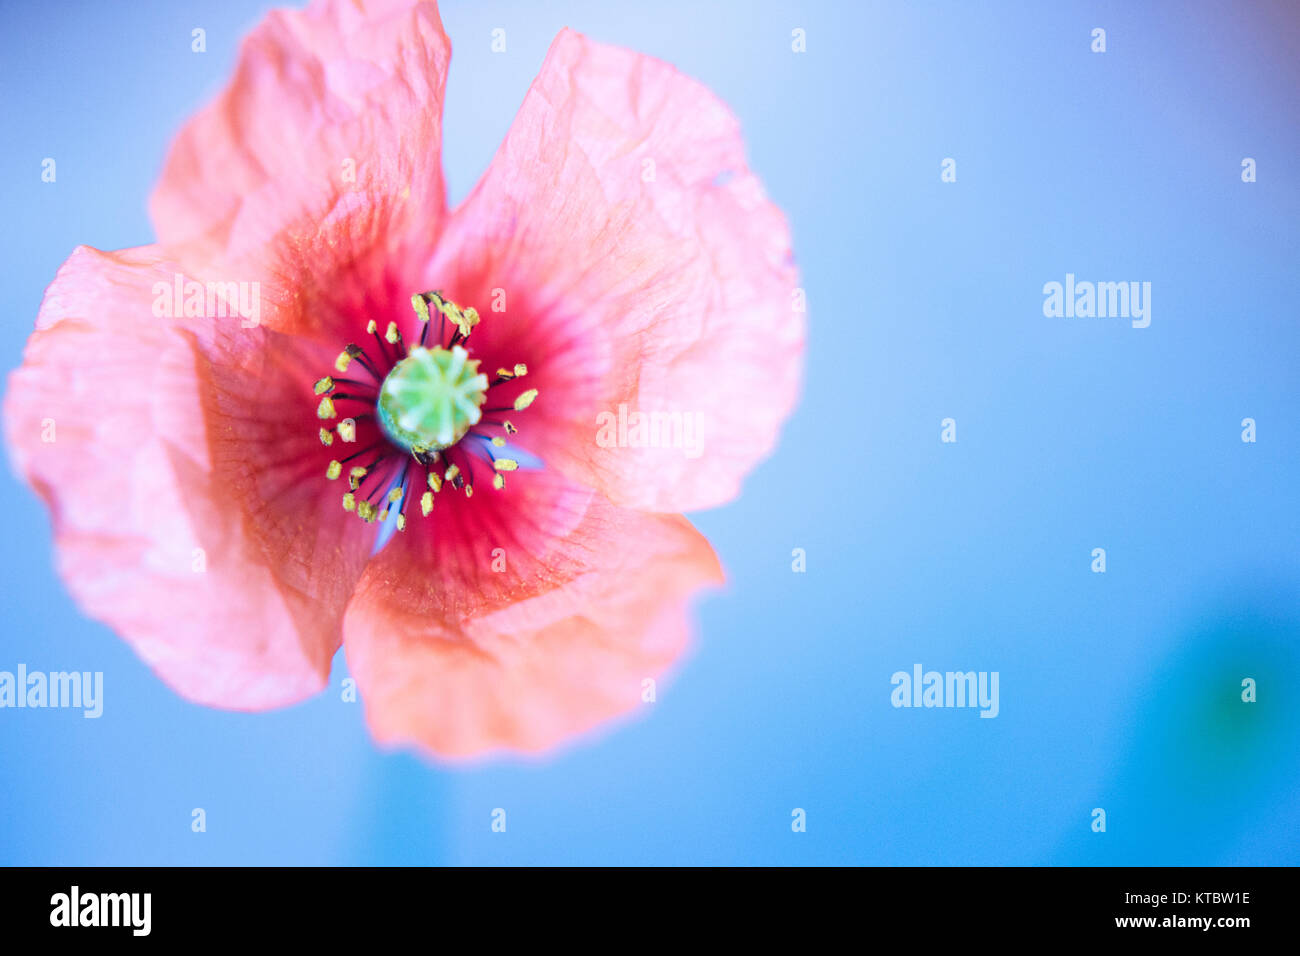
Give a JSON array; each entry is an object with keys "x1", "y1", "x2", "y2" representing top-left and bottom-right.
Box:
[{"x1": 430, "y1": 30, "x2": 803, "y2": 511}]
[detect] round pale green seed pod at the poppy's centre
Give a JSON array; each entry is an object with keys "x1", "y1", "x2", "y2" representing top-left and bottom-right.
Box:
[{"x1": 377, "y1": 345, "x2": 488, "y2": 453}]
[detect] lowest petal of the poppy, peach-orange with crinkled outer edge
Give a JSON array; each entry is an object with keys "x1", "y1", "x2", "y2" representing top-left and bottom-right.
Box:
[{"x1": 343, "y1": 496, "x2": 722, "y2": 757}]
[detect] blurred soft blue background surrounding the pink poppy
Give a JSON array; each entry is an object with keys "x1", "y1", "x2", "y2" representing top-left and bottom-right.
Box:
[{"x1": 0, "y1": 0, "x2": 1300, "y2": 864}]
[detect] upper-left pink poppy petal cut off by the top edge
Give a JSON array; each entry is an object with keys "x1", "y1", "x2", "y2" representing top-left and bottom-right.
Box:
[{"x1": 151, "y1": 0, "x2": 451, "y2": 334}]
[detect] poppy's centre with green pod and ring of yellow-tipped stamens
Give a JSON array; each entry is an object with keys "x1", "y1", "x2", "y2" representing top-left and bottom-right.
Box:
[{"x1": 313, "y1": 291, "x2": 537, "y2": 531}]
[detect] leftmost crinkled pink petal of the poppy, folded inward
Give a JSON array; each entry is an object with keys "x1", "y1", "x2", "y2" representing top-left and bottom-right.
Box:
[{"x1": 4, "y1": 246, "x2": 369, "y2": 709}]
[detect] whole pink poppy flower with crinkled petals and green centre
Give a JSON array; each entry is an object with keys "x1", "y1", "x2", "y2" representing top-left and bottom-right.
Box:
[{"x1": 5, "y1": 0, "x2": 803, "y2": 757}]
